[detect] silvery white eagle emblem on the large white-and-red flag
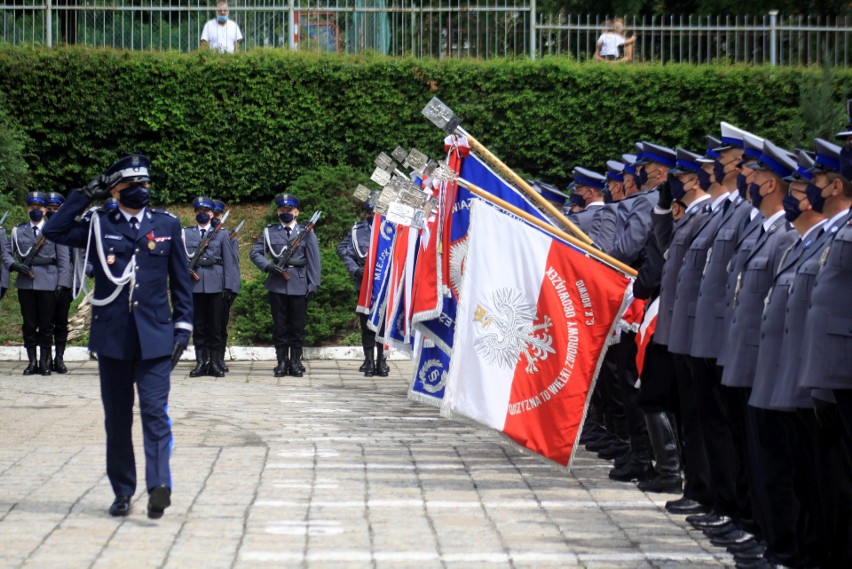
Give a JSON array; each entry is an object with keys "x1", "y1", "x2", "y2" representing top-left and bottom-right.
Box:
[{"x1": 473, "y1": 288, "x2": 556, "y2": 373}]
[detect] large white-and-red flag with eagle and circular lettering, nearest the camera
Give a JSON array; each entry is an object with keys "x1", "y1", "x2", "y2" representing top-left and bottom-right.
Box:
[{"x1": 442, "y1": 200, "x2": 630, "y2": 466}]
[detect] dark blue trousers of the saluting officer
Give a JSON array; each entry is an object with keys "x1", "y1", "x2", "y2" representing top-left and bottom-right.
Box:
[{"x1": 98, "y1": 356, "x2": 173, "y2": 496}]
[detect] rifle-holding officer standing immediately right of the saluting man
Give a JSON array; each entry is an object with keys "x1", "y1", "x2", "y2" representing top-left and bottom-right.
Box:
[{"x1": 183, "y1": 196, "x2": 234, "y2": 377}]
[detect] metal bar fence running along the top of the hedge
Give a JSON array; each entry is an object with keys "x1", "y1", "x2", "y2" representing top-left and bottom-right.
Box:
[{"x1": 0, "y1": 0, "x2": 852, "y2": 67}]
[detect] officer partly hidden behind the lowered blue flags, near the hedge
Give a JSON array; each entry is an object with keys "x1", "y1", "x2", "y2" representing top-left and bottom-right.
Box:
[{"x1": 337, "y1": 202, "x2": 390, "y2": 377}]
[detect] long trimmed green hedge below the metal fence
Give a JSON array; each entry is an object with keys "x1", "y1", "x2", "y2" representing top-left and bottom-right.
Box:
[{"x1": 0, "y1": 47, "x2": 852, "y2": 203}]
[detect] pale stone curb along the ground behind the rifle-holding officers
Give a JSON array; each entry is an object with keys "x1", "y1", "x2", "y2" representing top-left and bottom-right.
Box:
[{"x1": 0, "y1": 346, "x2": 411, "y2": 362}]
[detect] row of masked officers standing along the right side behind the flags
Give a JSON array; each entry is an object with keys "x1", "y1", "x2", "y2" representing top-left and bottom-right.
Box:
[{"x1": 564, "y1": 123, "x2": 852, "y2": 567}]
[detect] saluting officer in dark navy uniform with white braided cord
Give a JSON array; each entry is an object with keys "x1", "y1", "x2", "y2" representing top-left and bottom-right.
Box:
[{"x1": 44, "y1": 154, "x2": 192, "y2": 519}]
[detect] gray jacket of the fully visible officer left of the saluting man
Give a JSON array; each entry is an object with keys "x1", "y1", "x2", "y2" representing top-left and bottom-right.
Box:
[{"x1": 4, "y1": 222, "x2": 71, "y2": 291}]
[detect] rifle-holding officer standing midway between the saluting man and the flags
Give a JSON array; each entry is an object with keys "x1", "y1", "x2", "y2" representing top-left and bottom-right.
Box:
[{"x1": 249, "y1": 194, "x2": 320, "y2": 377}]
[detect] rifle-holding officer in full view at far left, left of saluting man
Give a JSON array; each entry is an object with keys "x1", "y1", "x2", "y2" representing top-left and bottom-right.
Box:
[{"x1": 4, "y1": 192, "x2": 70, "y2": 375}]
